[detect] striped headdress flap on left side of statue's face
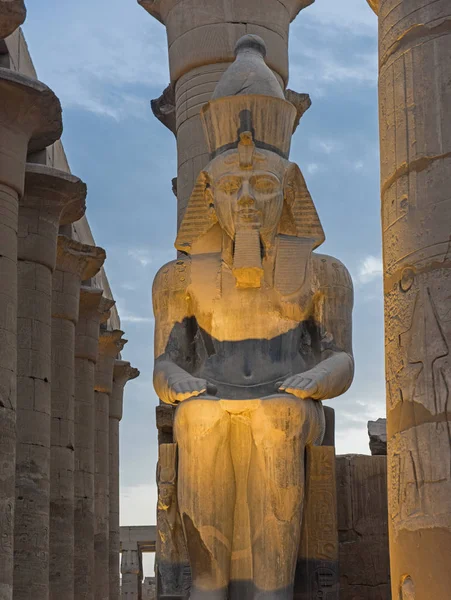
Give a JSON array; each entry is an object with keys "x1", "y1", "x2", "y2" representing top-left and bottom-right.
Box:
[{"x1": 175, "y1": 171, "x2": 218, "y2": 254}]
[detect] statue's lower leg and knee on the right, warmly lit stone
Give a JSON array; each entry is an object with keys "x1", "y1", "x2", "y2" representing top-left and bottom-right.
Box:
[{"x1": 248, "y1": 396, "x2": 324, "y2": 600}]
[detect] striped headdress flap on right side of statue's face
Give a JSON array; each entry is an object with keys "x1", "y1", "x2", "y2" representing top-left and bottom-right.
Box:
[{"x1": 280, "y1": 163, "x2": 325, "y2": 248}]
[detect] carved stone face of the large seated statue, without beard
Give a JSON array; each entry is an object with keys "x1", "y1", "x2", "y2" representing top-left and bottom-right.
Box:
[{"x1": 208, "y1": 150, "x2": 286, "y2": 240}]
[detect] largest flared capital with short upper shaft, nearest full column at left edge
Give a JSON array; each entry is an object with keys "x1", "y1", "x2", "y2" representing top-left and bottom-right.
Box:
[{"x1": 0, "y1": 67, "x2": 63, "y2": 195}]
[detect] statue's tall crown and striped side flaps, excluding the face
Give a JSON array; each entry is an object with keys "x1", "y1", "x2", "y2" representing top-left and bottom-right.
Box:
[{"x1": 175, "y1": 35, "x2": 325, "y2": 253}]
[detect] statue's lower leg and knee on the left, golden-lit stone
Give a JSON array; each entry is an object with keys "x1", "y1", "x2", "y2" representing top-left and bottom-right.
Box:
[{"x1": 174, "y1": 399, "x2": 235, "y2": 600}]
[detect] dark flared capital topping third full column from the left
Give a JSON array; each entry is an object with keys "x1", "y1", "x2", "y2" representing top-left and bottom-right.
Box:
[{"x1": 56, "y1": 235, "x2": 106, "y2": 281}]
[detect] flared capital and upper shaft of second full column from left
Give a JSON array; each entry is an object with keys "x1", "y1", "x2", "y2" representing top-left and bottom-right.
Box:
[{"x1": 18, "y1": 164, "x2": 86, "y2": 271}]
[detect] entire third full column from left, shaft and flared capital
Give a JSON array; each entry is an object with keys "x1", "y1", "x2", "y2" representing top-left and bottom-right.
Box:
[{"x1": 49, "y1": 235, "x2": 105, "y2": 600}]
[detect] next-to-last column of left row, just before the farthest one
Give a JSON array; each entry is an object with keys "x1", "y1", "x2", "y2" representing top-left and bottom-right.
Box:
[{"x1": 94, "y1": 330, "x2": 126, "y2": 600}]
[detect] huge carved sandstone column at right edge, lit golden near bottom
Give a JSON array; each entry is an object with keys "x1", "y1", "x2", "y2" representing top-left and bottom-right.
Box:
[{"x1": 371, "y1": 0, "x2": 451, "y2": 600}]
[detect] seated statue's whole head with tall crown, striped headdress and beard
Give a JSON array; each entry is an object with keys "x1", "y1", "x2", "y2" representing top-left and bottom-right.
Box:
[{"x1": 176, "y1": 36, "x2": 324, "y2": 287}]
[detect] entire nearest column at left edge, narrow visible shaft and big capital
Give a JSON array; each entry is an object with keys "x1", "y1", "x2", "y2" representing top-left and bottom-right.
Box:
[{"x1": 0, "y1": 69, "x2": 62, "y2": 600}]
